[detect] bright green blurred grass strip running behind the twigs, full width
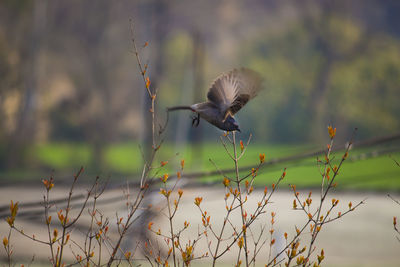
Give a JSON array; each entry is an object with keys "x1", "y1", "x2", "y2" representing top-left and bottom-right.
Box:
[{"x1": 18, "y1": 142, "x2": 400, "y2": 191}]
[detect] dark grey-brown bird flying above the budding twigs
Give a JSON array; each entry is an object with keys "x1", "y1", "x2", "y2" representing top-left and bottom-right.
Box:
[{"x1": 168, "y1": 68, "x2": 262, "y2": 132}]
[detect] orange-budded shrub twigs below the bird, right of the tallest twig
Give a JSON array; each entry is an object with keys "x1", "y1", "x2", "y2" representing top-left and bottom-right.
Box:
[{"x1": 143, "y1": 127, "x2": 364, "y2": 266}]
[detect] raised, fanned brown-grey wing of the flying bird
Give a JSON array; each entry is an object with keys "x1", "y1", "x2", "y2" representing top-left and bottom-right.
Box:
[{"x1": 207, "y1": 68, "x2": 262, "y2": 117}]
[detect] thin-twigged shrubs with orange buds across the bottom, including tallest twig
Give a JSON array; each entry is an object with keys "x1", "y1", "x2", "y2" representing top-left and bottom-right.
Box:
[{"x1": 3, "y1": 23, "x2": 362, "y2": 267}]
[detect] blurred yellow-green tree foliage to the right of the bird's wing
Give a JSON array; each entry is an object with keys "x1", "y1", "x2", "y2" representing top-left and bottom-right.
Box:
[{"x1": 245, "y1": 1, "x2": 400, "y2": 144}]
